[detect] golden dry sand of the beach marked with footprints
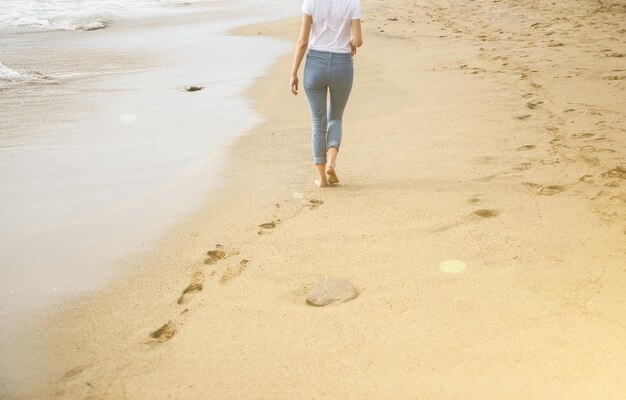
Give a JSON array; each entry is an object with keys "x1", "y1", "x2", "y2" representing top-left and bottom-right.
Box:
[{"x1": 7, "y1": 0, "x2": 626, "y2": 400}]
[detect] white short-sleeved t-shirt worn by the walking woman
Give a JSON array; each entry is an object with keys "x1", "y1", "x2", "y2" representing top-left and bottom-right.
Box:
[{"x1": 302, "y1": 0, "x2": 361, "y2": 53}]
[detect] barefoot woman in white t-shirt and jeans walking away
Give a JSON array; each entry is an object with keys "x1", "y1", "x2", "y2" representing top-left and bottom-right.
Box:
[{"x1": 291, "y1": 0, "x2": 363, "y2": 187}]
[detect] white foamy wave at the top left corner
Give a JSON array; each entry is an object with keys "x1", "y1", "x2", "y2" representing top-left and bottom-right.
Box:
[{"x1": 0, "y1": 0, "x2": 210, "y2": 32}]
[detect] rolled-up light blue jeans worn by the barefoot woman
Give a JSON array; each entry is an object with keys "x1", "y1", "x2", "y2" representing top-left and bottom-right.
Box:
[{"x1": 303, "y1": 50, "x2": 354, "y2": 164}]
